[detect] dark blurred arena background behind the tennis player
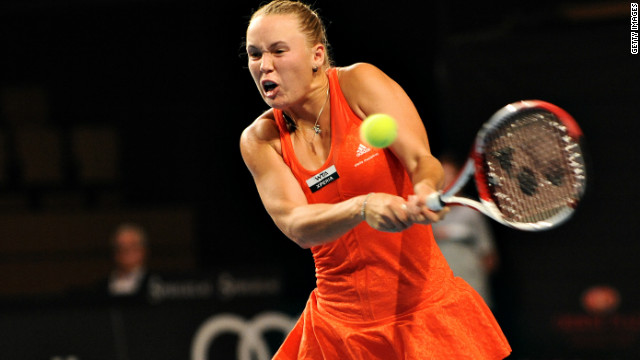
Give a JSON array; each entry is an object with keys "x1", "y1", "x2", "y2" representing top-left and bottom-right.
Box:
[{"x1": 0, "y1": 0, "x2": 640, "y2": 359}]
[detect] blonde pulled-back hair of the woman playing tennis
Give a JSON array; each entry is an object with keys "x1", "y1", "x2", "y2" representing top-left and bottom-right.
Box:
[{"x1": 249, "y1": 0, "x2": 332, "y2": 66}]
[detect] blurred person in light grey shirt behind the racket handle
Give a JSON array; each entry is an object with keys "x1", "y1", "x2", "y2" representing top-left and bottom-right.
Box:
[{"x1": 433, "y1": 155, "x2": 498, "y2": 307}]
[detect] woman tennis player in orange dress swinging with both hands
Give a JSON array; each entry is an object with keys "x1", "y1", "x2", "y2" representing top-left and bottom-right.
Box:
[{"x1": 240, "y1": 0, "x2": 511, "y2": 360}]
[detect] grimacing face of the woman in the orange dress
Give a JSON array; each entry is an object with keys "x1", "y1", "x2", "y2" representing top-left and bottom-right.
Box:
[{"x1": 247, "y1": 15, "x2": 317, "y2": 109}]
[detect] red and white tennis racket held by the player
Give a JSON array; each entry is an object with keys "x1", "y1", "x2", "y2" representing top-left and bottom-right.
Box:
[{"x1": 427, "y1": 100, "x2": 587, "y2": 231}]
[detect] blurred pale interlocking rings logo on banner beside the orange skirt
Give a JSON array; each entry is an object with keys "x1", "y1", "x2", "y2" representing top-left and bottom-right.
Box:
[{"x1": 191, "y1": 312, "x2": 296, "y2": 360}]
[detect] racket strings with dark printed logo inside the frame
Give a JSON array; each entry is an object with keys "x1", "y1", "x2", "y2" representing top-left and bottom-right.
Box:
[{"x1": 484, "y1": 109, "x2": 585, "y2": 223}]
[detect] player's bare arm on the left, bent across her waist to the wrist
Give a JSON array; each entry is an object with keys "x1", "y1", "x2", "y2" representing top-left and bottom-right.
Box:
[{"x1": 240, "y1": 112, "x2": 390, "y2": 248}]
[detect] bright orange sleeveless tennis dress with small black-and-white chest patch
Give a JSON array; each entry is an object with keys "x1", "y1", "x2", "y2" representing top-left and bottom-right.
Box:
[{"x1": 274, "y1": 68, "x2": 511, "y2": 360}]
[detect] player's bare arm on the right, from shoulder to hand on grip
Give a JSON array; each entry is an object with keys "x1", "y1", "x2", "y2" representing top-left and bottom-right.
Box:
[{"x1": 339, "y1": 63, "x2": 448, "y2": 223}]
